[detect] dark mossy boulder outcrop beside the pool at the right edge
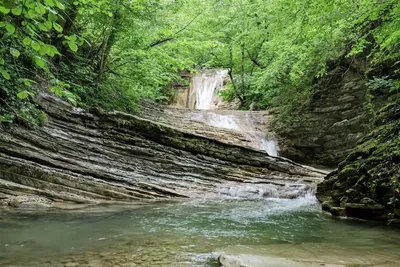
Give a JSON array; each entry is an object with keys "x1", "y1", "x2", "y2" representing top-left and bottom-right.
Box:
[{"x1": 317, "y1": 98, "x2": 400, "y2": 222}]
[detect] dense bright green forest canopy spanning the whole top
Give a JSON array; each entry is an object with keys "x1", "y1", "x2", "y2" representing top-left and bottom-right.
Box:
[{"x1": 0, "y1": 0, "x2": 400, "y2": 123}]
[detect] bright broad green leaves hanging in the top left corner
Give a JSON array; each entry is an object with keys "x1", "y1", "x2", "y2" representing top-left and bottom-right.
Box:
[{"x1": 0, "y1": 0, "x2": 72, "y2": 99}]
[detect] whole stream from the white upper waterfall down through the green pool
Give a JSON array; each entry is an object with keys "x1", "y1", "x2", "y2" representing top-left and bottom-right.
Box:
[{"x1": 0, "y1": 71, "x2": 400, "y2": 267}]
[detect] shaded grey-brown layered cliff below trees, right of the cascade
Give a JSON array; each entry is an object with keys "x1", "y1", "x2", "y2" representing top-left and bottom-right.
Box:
[{"x1": 277, "y1": 60, "x2": 367, "y2": 166}]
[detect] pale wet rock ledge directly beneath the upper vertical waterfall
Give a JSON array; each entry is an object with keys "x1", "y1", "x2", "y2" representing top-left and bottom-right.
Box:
[{"x1": 139, "y1": 101, "x2": 276, "y2": 154}]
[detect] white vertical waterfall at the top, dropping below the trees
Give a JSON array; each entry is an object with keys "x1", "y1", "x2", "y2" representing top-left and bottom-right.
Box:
[{"x1": 191, "y1": 70, "x2": 227, "y2": 109}]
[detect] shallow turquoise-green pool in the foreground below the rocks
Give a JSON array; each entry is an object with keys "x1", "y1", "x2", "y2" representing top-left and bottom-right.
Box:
[{"x1": 0, "y1": 196, "x2": 400, "y2": 266}]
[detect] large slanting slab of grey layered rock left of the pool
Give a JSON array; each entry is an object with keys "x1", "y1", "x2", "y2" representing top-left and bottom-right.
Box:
[{"x1": 0, "y1": 95, "x2": 323, "y2": 207}]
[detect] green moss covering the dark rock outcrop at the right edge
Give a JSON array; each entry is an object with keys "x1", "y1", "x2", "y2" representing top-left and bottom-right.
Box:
[{"x1": 317, "y1": 102, "x2": 400, "y2": 222}]
